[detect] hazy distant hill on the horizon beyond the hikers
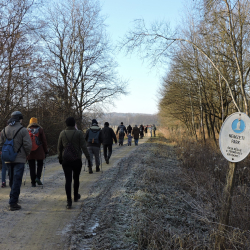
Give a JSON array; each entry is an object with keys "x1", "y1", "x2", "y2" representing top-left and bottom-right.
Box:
[{"x1": 98, "y1": 112, "x2": 158, "y2": 126}]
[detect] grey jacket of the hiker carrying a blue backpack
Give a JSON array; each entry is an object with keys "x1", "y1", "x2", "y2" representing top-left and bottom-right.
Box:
[{"x1": 0, "y1": 122, "x2": 32, "y2": 163}]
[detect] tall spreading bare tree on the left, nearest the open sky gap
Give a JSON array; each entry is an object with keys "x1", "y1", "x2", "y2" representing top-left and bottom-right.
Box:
[{"x1": 42, "y1": 0, "x2": 126, "y2": 129}]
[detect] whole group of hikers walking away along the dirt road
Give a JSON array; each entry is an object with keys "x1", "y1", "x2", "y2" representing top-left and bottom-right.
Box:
[{"x1": 0, "y1": 111, "x2": 156, "y2": 211}]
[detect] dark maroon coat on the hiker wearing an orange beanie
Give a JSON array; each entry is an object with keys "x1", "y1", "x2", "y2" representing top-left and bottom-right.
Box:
[{"x1": 27, "y1": 123, "x2": 48, "y2": 160}]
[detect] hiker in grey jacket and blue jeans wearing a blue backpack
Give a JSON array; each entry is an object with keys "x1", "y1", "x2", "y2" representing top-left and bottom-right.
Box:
[{"x1": 0, "y1": 111, "x2": 32, "y2": 211}]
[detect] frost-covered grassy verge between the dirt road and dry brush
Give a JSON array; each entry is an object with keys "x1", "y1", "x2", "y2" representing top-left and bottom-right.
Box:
[{"x1": 69, "y1": 138, "x2": 211, "y2": 250}]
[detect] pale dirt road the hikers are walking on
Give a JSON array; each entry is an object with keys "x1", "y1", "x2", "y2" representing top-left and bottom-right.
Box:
[{"x1": 0, "y1": 139, "x2": 146, "y2": 250}]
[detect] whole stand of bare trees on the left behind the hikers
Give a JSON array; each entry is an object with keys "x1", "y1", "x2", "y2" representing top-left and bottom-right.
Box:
[{"x1": 0, "y1": 0, "x2": 125, "y2": 152}]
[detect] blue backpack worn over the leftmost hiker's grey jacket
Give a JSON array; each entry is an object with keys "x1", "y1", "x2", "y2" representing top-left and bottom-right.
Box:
[{"x1": 2, "y1": 127, "x2": 23, "y2": 162}]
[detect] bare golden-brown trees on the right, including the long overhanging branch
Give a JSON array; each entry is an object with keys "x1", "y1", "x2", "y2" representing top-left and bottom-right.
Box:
[{"x1": 121, "y1": 0, "x2": 250, "y2": 144}]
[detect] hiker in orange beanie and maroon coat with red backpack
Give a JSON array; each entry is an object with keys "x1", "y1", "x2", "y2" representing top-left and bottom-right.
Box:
[{"x1": 27, "y1": 117, "x2": 48, "y2": 187}]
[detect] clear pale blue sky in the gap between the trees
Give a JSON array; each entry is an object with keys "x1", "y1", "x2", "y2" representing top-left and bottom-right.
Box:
[{"x1": 100, "y1": 0, "x2": 184, "y2": 114}]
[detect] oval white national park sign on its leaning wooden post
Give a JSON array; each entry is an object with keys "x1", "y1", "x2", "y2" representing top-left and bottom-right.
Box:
[{"x1": 215, "y1": 112, "x2": 250, "y2": 249}]
